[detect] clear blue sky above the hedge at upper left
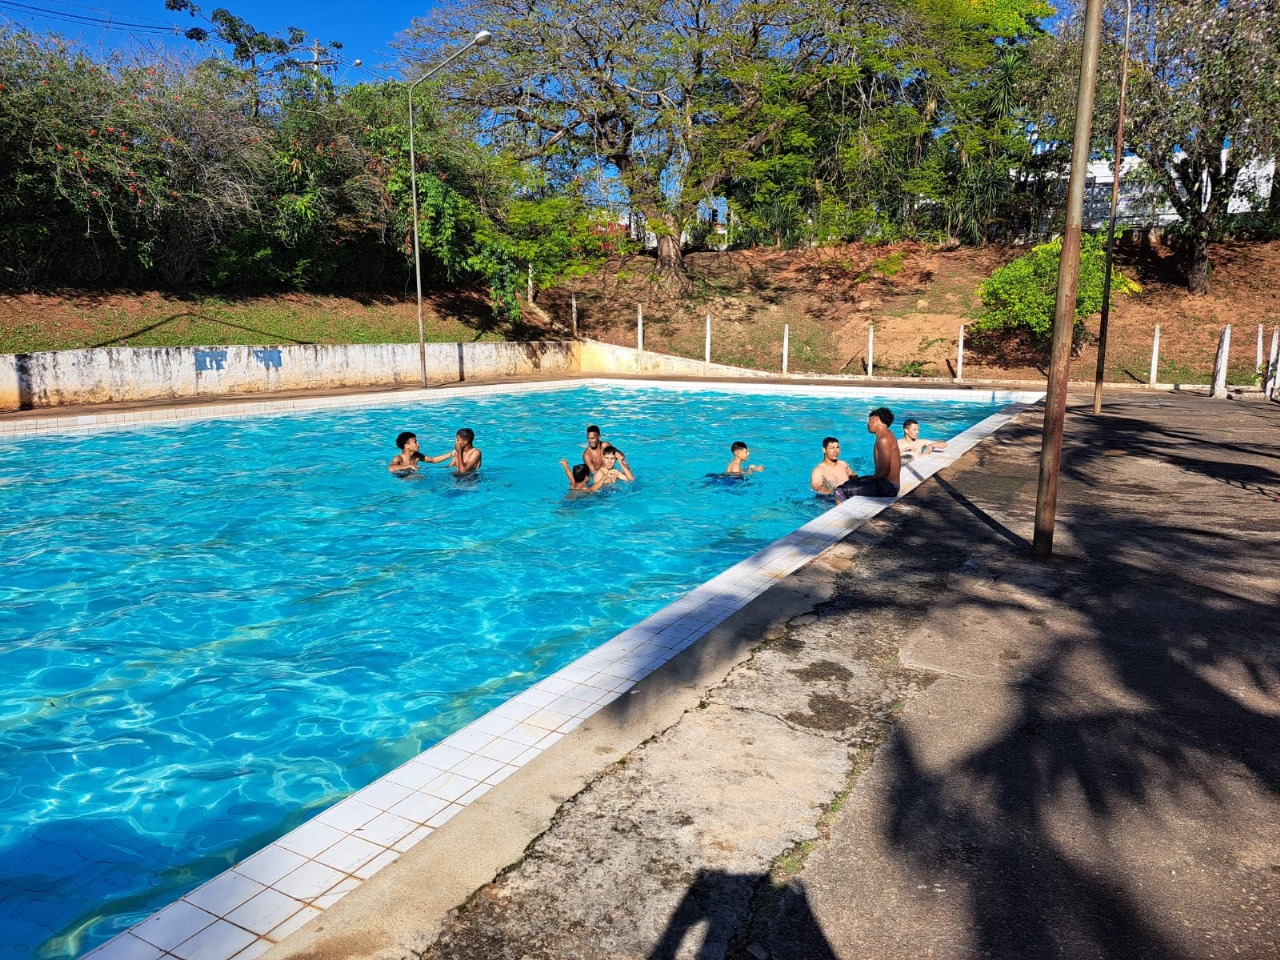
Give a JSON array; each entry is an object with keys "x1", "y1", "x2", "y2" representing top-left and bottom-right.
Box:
[{"x1": 0, "y1": 0, "x2": 431, "y2": 83}]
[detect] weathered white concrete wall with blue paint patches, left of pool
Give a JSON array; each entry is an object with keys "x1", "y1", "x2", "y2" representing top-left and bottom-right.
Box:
[{"x1": 0, "y1": 342, "x2": 577, "y2": 410}]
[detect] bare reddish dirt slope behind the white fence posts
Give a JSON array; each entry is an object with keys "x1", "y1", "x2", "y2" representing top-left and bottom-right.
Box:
[{"x1": 541, "y1": 242, "x2": 1280, "y2": 383}]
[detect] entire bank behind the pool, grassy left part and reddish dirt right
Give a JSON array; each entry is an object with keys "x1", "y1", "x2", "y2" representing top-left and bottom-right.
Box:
[{"x1": 0, "y1": 242, "x2": 1280, "y2": 383}]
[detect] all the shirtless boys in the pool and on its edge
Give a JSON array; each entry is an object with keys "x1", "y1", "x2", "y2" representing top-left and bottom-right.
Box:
[{"x1": 388, "y1": 407, "x2": 946, "y2": 503}]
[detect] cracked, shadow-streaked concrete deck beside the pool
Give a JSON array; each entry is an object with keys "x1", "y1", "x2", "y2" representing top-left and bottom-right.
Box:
[{"x1": 254, "y1": 392, "x2": 1280, "y2": 960}]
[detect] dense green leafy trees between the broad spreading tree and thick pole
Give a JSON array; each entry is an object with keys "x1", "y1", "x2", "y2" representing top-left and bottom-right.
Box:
[{"x1": 727, "y1": 0, "x2": 1050, "y2": 243}]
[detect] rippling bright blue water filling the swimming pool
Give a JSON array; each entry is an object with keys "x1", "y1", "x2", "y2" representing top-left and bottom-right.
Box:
[{"x1": 0, "y1": 388, "x2": 993, "y2": 960}]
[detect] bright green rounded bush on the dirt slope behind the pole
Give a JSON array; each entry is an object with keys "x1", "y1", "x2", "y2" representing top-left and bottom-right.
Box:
[{"x1": 973, "y1": 236, "x2": 1142, "y2": 344}]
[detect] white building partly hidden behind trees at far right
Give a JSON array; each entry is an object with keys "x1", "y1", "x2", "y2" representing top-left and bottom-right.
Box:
[{"x1": 1084, "y1": 154, "x2": 1276, "y2": 230}]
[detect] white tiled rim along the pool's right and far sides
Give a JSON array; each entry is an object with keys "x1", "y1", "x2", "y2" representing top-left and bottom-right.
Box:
[{"x1": 74, "y1": 379, "x2": 1042, "y2": 960}]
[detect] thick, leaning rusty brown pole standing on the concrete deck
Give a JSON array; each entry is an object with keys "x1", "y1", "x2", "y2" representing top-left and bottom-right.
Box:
[{"x1": 1032, "y1": 0, "x2": 1102, "y2": 561}]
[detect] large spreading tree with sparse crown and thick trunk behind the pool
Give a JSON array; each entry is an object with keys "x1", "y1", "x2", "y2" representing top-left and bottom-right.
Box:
[{"x1": 402, "y1": 0, "x2": 855, "y2": 289}]
